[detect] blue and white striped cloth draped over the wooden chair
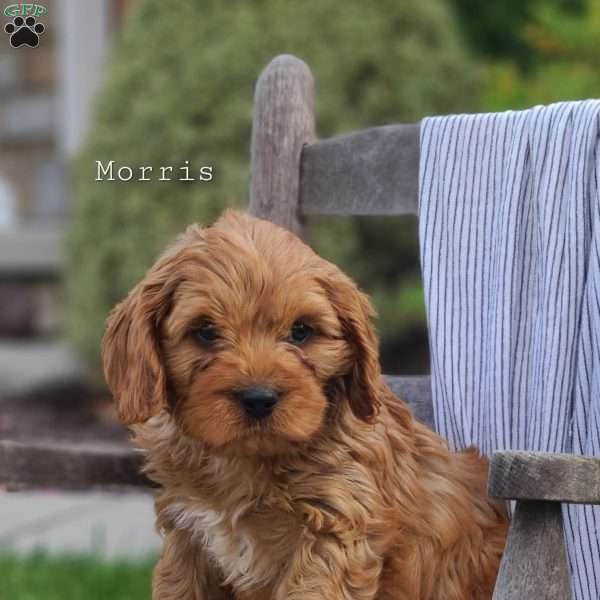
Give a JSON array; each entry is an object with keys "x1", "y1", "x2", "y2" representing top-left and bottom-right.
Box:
[{"x1": 419, "y1": 101, "x2": 600, "y2": 600}]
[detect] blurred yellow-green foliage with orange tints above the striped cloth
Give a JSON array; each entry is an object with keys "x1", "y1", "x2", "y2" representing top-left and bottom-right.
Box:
[{"x1": 483, "y1": 0, "x2": 600, "y2": 110}]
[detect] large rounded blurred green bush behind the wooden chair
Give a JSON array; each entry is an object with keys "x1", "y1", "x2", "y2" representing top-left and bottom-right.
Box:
[{"x1": 67, "y1": 0, "x2": 478, "y2": 364}]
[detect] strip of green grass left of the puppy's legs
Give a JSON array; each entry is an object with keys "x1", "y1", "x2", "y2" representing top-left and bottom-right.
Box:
[{"x1": 0, "y1": 553, "x2": 155, "y2": 600}]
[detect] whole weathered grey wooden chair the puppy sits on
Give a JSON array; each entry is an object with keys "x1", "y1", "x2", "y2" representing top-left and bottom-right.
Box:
[{"x1": 0, "y1": 56, "x2": 600, "y2": 600}]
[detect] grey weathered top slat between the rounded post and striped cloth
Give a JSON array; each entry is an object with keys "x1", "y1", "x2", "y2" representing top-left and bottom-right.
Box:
[{"x1": 300, "y1": 124, "x2": 420, "y2": 215}]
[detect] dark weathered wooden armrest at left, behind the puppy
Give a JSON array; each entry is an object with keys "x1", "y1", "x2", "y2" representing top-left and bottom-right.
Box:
[{"x1": 0, "y1": 440, "x2": 153, "y2": 491}]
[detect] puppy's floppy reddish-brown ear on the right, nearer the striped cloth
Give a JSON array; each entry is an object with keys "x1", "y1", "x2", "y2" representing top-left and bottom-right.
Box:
[{"x1": 321, "y1": 265, "x2": 381, "y2": 422}]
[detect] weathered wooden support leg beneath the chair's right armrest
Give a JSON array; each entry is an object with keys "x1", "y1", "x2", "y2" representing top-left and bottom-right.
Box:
[{"x1": 493, "y1": 500, "x2": 571, "y2": 600}]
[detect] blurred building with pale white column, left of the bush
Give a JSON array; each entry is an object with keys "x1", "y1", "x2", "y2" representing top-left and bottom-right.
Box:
[{"x1": 0, "y1": 0, "x2": 127, "y2": 337}]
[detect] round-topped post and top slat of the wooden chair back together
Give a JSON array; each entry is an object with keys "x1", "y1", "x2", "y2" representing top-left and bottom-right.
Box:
[{"x1": 249, "y1": 55, "x2": 420, "y2": 227}]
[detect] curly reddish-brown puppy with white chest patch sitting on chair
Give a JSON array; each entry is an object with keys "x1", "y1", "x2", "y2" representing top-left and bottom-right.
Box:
[{"x1": 103, "y1": 211, "x2": 506, "y2": 600}]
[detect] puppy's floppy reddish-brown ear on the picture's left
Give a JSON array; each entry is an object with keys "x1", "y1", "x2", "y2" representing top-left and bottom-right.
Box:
[{"x1": 102, "y1": 226, "x2": 202, "y2": 425}]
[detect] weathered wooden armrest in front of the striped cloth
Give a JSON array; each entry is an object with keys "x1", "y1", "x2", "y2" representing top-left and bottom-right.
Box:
[{"x1": 488, "y1": 452, "x2": 600, "y2": 504}]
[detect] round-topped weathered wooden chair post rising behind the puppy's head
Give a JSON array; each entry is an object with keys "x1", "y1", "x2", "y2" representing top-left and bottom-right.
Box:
[{"x1": 249, "y1": 55, "x2": 315, "y2": 235}]
